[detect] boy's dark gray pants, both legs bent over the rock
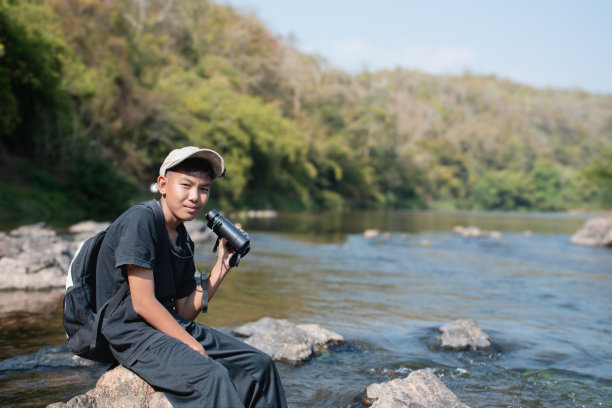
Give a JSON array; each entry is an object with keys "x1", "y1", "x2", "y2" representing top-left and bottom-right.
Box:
[{"x1": 129, "y1": 322, "x2": 287, "y2": 408}]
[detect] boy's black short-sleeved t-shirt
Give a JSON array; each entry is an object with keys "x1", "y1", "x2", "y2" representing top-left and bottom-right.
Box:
[{"x1": 96, "y1": 200, "x2": 196, "y2": 366}]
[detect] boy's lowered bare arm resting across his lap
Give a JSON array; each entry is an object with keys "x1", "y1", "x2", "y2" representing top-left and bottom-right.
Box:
[{"x1": 127, "y1": 265, "x2": 207, "y2": 356}]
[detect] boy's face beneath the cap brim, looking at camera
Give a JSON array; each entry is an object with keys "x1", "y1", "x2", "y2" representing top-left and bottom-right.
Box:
[{"x1": 157, "y1": 171, "x2": 211, "y2": 225}]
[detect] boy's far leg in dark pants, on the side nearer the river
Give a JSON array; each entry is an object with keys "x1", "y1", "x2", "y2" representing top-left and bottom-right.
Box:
[{"x1": 186, "y1": 323, "x2": 287, "y2": 408}]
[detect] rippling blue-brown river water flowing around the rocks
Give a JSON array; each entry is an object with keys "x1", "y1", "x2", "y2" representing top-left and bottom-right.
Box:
[{"x1": 0, "y1": 211, "x2": 612, "y2": 407}]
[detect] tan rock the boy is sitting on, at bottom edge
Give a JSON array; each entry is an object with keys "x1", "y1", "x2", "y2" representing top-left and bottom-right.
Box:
[{"x1": 47, "y1": 366, "x2": 172, "y2": 408}]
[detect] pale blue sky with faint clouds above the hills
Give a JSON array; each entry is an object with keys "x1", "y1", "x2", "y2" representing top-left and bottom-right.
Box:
[{"x1": 218, "y1": 0, "x2": 612, "y2": 94}]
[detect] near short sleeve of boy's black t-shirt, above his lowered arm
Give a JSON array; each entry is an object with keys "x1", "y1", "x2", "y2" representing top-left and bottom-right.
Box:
[{"x1": 115, "y1": 206, "x2": 158, "y2": 270}]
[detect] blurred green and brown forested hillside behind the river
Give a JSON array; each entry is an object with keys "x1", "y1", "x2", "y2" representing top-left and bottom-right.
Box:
[{"x1": 0, "y1": 0, "x2": 612, "y2": 222}]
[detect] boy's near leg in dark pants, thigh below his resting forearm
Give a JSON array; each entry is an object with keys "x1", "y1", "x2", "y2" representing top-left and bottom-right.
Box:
[{"x1": 129, "y1": 336, "x2": 243, "y2": 407}]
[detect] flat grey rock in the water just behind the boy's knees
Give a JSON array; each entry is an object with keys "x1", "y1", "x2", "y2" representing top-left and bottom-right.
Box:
[{"x1": 233, "y1": 317, "x2": 344, "y2": 364}]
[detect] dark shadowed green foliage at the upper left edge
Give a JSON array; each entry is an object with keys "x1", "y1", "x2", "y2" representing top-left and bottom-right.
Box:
[{"x1": 0, "y1": 0, "x2": 66, "y2": 156}]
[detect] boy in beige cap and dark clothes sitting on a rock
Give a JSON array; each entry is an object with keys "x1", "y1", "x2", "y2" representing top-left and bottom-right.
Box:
[{"x1": 96, "y1": 146, "x2": 287, "y2": 407}]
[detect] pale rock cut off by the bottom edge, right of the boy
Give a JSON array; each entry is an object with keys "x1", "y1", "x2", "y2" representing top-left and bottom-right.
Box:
[{"x1": 364, "y1": 370, "x2": 469, "y2": 408}]
